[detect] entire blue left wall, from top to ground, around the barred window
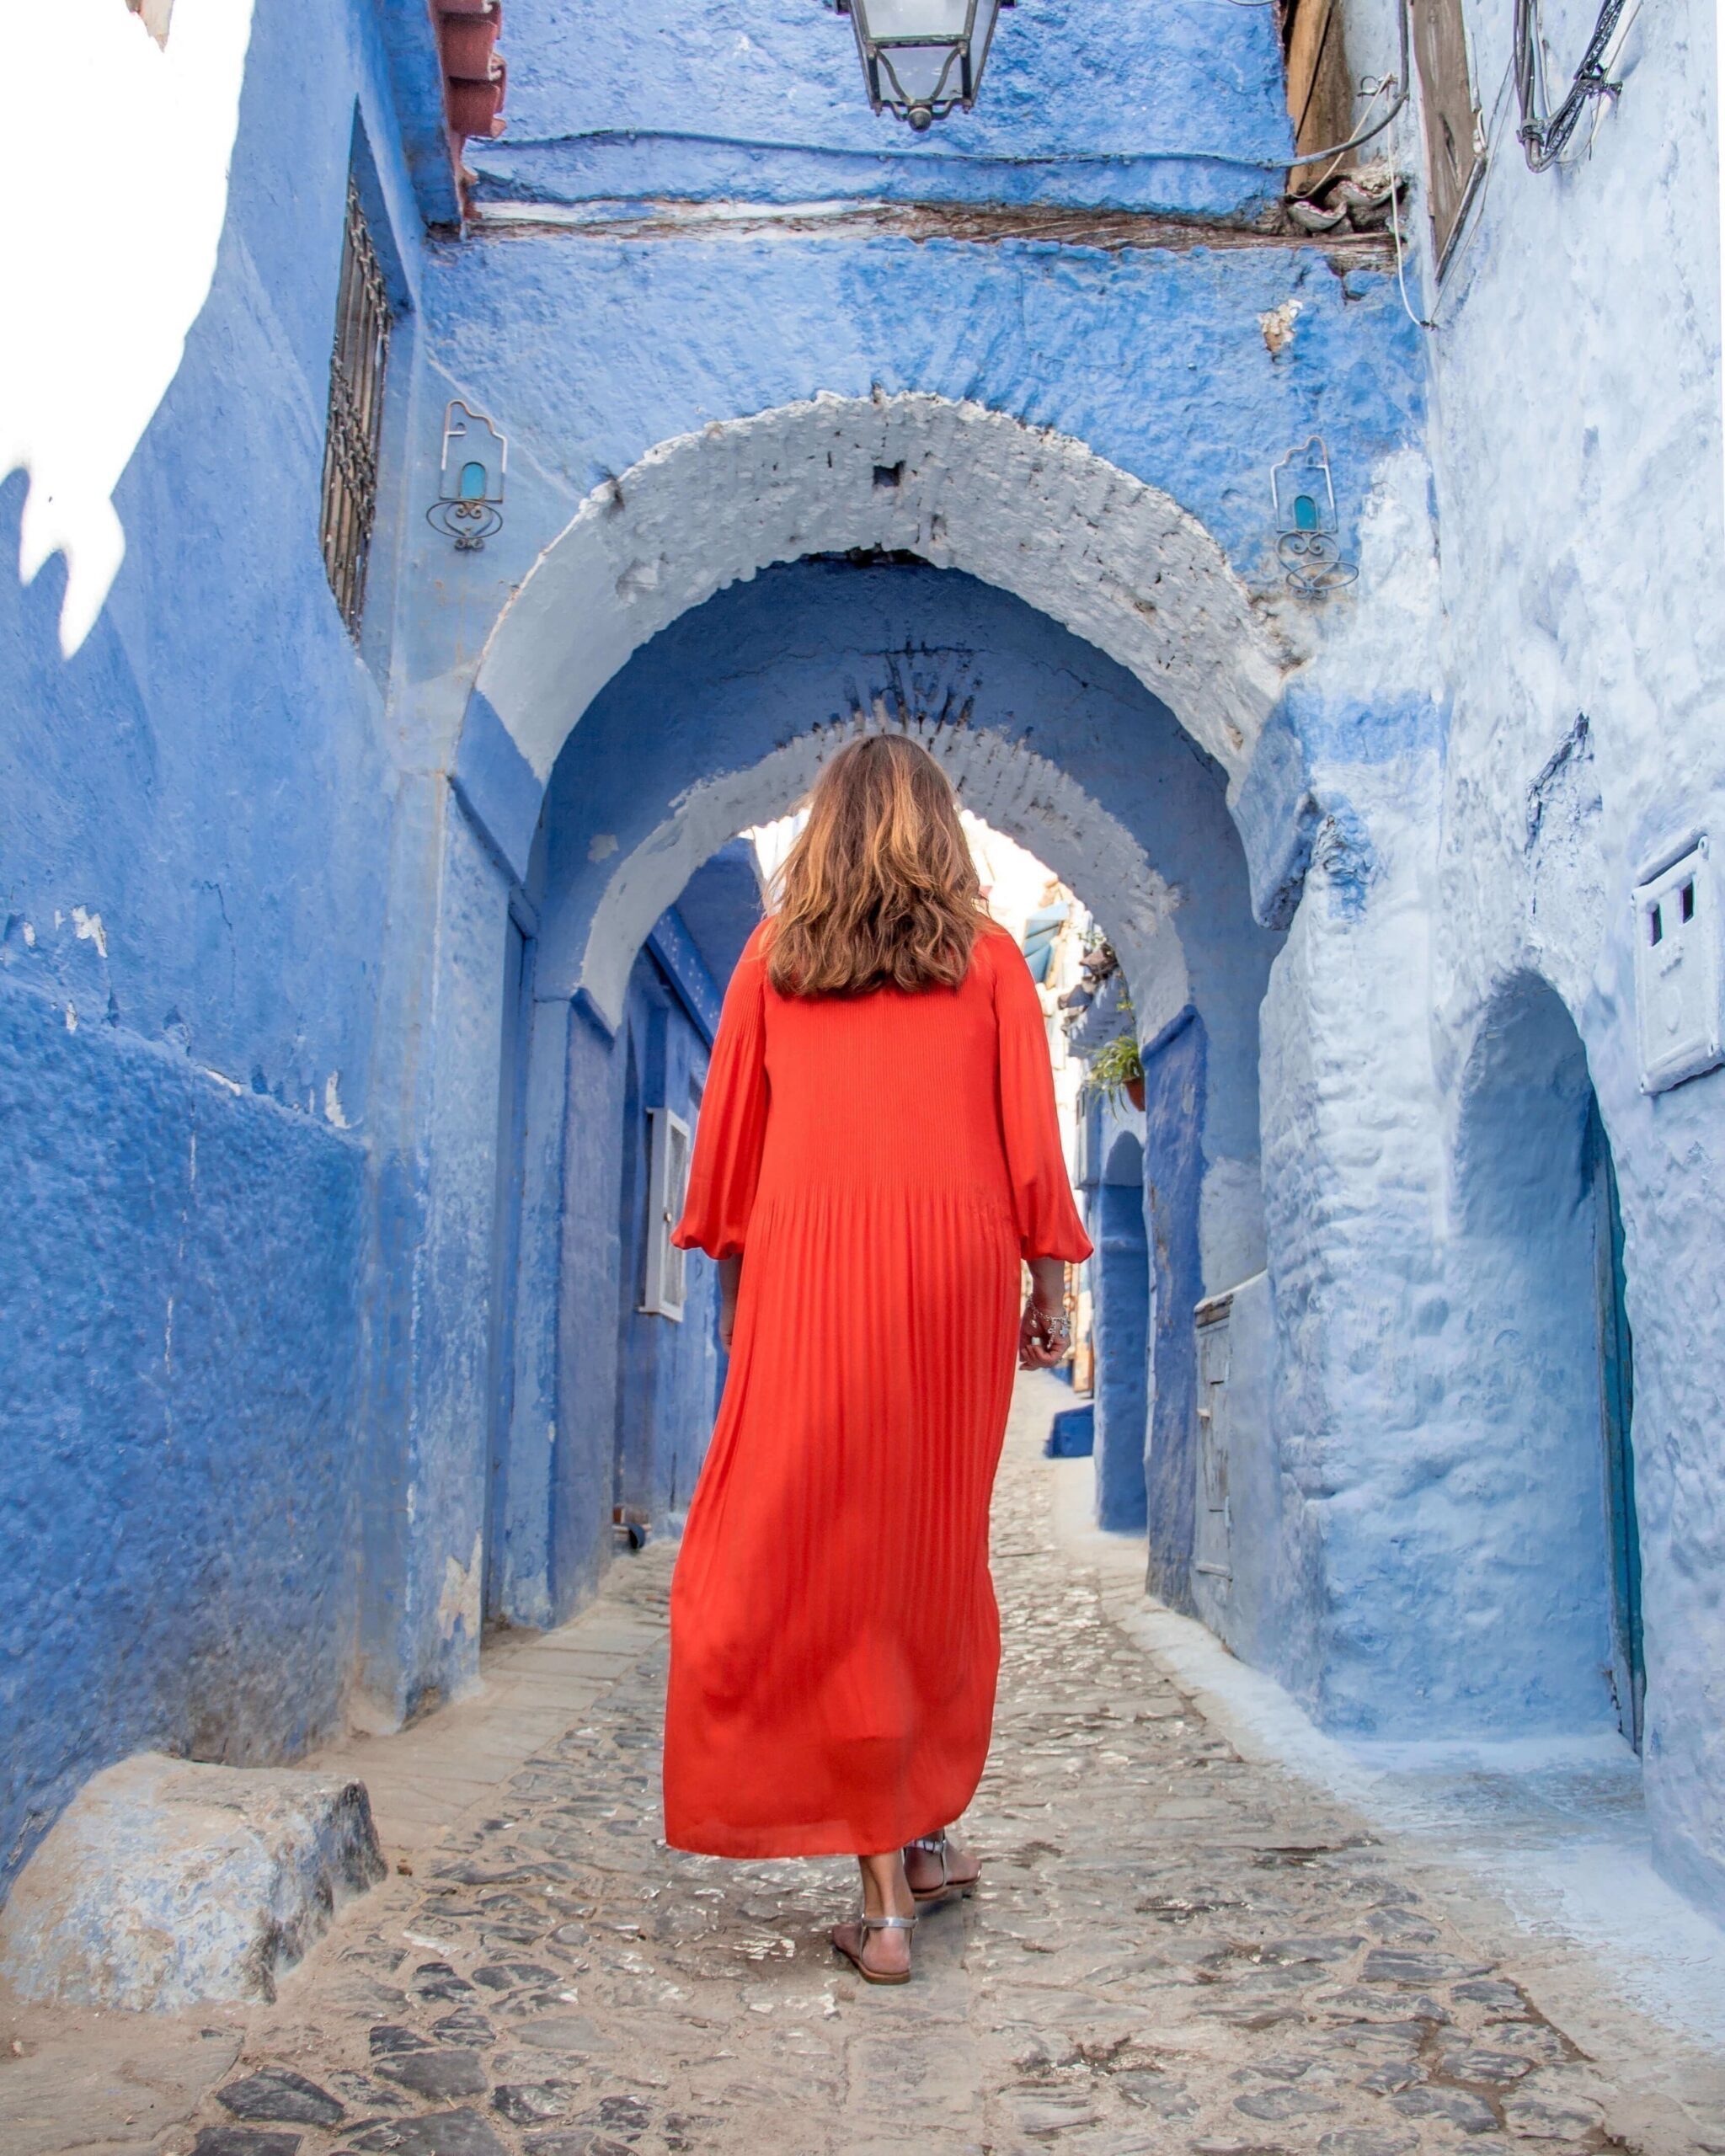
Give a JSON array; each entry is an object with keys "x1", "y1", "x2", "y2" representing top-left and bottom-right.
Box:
[{"x1": 0, "y1": 0, "x2": 419, "y2": 1884}]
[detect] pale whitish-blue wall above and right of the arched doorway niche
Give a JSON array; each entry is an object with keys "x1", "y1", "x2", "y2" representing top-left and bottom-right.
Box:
[{"x1": 1371, "y1": 0, "x2": 1725, "y2": 1913}]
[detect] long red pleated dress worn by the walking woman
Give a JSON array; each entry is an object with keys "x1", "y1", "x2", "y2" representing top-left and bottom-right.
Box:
[{"x1": 664, "y1": 923, "x2": 1091, "y2": 1856}]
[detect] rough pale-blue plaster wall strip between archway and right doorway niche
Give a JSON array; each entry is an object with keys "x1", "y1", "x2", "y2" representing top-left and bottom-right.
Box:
[{"x1": 1262, "y1": 755, "x2": 1455, "y2": 1733}]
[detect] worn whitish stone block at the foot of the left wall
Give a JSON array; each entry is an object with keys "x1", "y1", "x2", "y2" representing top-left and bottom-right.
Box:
[{"x1": 0, "y1": 1753, "x2": 384, "y2": 2011}]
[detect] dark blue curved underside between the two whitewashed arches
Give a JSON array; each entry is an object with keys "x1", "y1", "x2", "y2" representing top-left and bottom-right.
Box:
[{"x1": 543, "y1": 561, "x2": 1281, "y2": 1155}]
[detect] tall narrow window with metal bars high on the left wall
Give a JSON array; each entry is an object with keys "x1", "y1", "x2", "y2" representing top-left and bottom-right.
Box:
[{"x1": 323, "y1": 179, "x2": 390, "y2": 634}]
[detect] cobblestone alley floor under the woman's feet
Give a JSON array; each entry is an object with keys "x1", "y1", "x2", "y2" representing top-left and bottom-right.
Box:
[{"x1": 0, "y1": 1401, "x2": 1725, "y2": 2156}]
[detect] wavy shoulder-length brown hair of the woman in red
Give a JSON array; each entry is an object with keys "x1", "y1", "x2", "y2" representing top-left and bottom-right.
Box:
[{"x1": 767, "y1": 733, "x2": 983, "y2": 996}]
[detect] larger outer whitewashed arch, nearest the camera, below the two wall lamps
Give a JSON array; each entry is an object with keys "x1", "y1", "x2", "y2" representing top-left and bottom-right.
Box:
[{"x1": 477, "y1": 394, "x2": 1283, "y2": 785}]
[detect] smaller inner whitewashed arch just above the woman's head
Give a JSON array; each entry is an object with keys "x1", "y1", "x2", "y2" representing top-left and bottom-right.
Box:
[{"x1": 576, "y1": 705, "x2": 1190, "y2": 1039}]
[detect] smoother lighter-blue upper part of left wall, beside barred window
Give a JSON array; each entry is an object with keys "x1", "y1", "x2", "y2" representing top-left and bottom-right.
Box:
[{"x1": 0, "y1": 0, "x2": 426, "y2": 1117}]
